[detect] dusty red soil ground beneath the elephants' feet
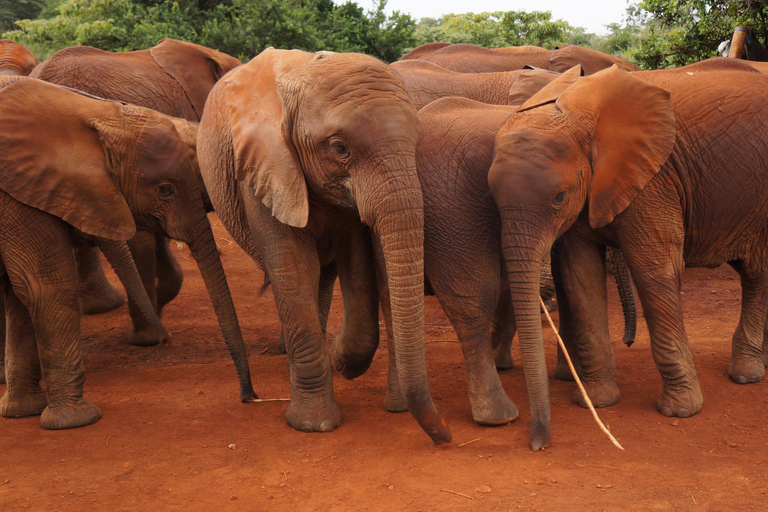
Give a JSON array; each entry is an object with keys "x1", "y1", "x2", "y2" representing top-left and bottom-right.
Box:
[{"x1": 0, "y1": 216, "x2": 768, "y2": 511}]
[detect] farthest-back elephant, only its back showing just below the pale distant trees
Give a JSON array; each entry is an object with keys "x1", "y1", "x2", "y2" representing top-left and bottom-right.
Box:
[{"x1": 416, "y1": 44, "x2": 639, "y2": 75}]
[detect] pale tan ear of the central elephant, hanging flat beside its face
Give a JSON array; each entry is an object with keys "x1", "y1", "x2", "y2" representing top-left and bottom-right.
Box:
[{"x1": 224, "y1": 48, "x2": 312, "y2": 228}]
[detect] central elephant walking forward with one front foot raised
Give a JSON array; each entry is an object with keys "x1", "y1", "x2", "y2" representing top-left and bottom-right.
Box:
[{"x1": 198, "y1": 49, "x2": 451, "y2": 444}]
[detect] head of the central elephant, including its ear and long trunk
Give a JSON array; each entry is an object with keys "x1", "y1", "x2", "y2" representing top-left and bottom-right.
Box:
[{"x1": 198, "y1": 49, "x2": 450, "y2": 443}]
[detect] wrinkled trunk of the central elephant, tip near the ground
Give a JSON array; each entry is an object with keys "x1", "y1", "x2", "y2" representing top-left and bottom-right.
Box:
[{"x1": 358, "y1": 165, "x2": 451, "y2": 444}]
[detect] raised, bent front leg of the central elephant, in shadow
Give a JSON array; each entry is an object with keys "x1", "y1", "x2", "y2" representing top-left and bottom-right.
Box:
[{"x1": 332, "y1": 226, "x2": 379, "y2": 379}]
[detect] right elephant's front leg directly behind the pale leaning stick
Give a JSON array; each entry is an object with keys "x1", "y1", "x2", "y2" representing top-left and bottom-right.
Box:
[{"x1": 552, "y1": 232, "x2": 620, "y2": 407}]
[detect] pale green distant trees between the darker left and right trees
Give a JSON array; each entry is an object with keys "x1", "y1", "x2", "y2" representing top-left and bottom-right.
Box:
[{"x1": 416, "y1": 11, "x2": 590, "y2": 48}]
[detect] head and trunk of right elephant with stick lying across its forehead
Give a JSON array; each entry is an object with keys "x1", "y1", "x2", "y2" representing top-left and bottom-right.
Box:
[{"x1": 488, "y1": 66, "x2": 675, "y2": 450}]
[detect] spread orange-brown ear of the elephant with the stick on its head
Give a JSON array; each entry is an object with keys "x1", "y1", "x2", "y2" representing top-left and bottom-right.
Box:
[{"x1": 557, "y1": 66, "x2": 676, "y2": 229}]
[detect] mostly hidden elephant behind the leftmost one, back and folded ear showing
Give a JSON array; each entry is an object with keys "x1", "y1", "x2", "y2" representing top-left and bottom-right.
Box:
[{"x1": 32, "y1": 39, "x2": 240, "y2": 346}]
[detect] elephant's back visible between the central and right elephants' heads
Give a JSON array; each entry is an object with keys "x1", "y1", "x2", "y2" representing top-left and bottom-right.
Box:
[{"x1": 390, "y1": 59, "x2": 560, "y2": 109}]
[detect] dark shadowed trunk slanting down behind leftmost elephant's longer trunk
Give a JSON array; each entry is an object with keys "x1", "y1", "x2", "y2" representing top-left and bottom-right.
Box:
[{"x1": 97, "y1": 238, "x2": 170, "y2": 340}]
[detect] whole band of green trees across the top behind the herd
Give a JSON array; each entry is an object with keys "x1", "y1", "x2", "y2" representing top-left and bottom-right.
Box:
[{"x1": 0, "y1": 0, "x2": 768, "y2": 69}]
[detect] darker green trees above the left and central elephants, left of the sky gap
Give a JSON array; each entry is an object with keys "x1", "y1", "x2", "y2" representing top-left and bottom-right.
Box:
[{"x1": 0, "y1": 0, "x2": 415, "y2": 61}]
